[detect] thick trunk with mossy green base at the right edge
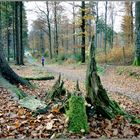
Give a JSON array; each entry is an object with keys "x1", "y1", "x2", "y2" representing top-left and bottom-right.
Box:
[{"x1": 133, "y1": 1, "x2": 140, "y2": 66}]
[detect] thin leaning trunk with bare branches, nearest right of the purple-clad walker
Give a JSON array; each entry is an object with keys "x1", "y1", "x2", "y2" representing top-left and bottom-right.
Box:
[{"x1": 46, "y1": 1, "x2": 52, "y2": 59}]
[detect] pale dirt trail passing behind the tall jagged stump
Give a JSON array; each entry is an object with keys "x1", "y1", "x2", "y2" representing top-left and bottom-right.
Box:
[{"x1": 44, "y1": 65, "x2": 140, "y2": 102}]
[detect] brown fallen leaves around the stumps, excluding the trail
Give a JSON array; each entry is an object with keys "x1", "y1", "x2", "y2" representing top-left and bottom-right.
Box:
[{"x1": 0, "y1": 64, "x2": 140, "y2": 139}]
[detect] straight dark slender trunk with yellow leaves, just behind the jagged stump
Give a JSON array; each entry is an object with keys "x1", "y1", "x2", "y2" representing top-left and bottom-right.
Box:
[{"x1": 81, "y1": 1, "x2": 86, "y2": 63}]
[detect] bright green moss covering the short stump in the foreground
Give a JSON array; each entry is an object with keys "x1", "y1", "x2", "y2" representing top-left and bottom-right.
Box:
[{"x1": 67, "y1": 95, "x2": 89, "y2": 133}]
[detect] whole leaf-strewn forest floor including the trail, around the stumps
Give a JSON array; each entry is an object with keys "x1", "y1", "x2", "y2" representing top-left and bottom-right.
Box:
[{"x1": 0, "y1": 63, "x2": 140, "y2": 138}]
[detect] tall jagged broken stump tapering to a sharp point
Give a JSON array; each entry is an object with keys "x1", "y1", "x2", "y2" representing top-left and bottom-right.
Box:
[{"x1": 86, "y1": 36, "x2": 124, "y2": 119}]
